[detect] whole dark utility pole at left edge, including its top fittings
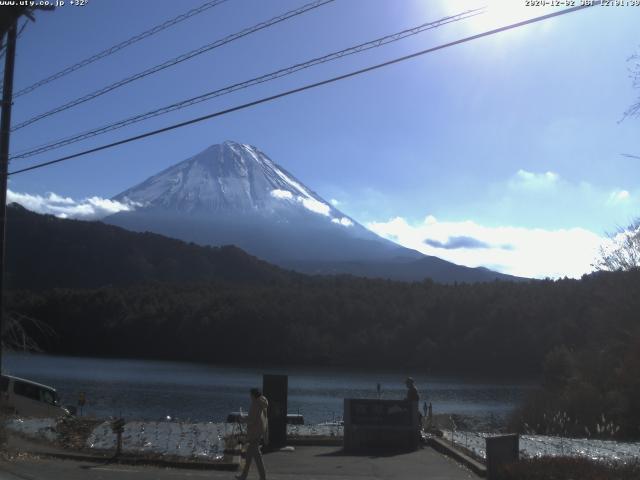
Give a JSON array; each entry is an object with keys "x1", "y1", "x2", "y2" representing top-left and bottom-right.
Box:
[{"x1": 0, "y1": 6, "x2": 53, "y2": 373}]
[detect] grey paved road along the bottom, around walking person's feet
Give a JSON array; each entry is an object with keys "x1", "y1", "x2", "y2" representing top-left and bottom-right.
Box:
[{"x1": 0, "y1": 447, "x2": 478, "y2": 480}]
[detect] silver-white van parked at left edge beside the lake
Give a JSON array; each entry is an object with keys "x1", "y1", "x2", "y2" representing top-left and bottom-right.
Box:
[{"x1": 0, "y1": 375, "x2": 69, "y2": 417}]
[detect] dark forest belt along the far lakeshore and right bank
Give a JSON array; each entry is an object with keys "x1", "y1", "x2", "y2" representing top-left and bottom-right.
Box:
[{"x1": 7, "y1": 269, "x2": 640, "y2": 437}]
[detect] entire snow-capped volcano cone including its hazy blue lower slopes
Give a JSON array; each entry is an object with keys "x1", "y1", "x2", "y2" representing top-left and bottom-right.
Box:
[{"x1": 104, "y1": 141, "x2": 520, "y2": 282}]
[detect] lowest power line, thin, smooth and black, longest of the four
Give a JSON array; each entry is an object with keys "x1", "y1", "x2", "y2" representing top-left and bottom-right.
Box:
[{"x1": 9, "y1": 2, "x2": 599, "y2": 175}]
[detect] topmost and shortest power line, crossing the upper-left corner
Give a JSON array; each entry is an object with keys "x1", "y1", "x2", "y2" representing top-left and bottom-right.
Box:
[{"x1": 13, "y1": 0, "x2": 227, "y2": 97}]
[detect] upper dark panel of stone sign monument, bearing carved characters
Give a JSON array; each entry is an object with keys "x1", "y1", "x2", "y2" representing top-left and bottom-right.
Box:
[{"x1": 349, "y1": 399, "x2": 417, "y2": 427}]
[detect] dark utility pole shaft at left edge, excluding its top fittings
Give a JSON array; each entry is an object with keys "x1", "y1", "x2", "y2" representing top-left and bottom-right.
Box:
[{"x1": 0, "y1": 19, "x2": 18, "y2": 372}]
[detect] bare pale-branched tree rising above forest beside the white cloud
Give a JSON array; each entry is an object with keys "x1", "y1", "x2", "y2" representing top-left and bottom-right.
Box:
[{"x1": 595, "y1": 218, "x2": 640, "y2": 271}]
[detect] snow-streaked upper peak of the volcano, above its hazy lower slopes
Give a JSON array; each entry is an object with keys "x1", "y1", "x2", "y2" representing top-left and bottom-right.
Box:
[{"x1": 114, "y1": 140, "x2": 354, "y2": 227}]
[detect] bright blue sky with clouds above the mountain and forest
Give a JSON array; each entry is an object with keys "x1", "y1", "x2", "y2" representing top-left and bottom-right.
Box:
[{"x1": 9, "y1": 0, "x2": 640, "y2": 277}]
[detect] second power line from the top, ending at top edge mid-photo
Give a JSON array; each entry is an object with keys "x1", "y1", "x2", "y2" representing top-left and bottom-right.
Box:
[{"x1": 11, "y1": 0, "x2": 335, "y2": 132}]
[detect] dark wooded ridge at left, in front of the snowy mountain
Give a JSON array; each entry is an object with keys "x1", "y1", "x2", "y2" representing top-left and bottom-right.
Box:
[{"x1": 6, "y1": 204, "x2": 301, "y2": 289}]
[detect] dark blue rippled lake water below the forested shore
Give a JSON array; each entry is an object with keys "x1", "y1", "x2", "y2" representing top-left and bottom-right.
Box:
[{"x1": 3, "y1": 353, "x2": 534, "y2": 423}]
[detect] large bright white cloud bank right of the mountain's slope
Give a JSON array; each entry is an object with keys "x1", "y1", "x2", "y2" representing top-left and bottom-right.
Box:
[{"x1": 367, "y1": 215, "x2": 604, "y2": 278}]
